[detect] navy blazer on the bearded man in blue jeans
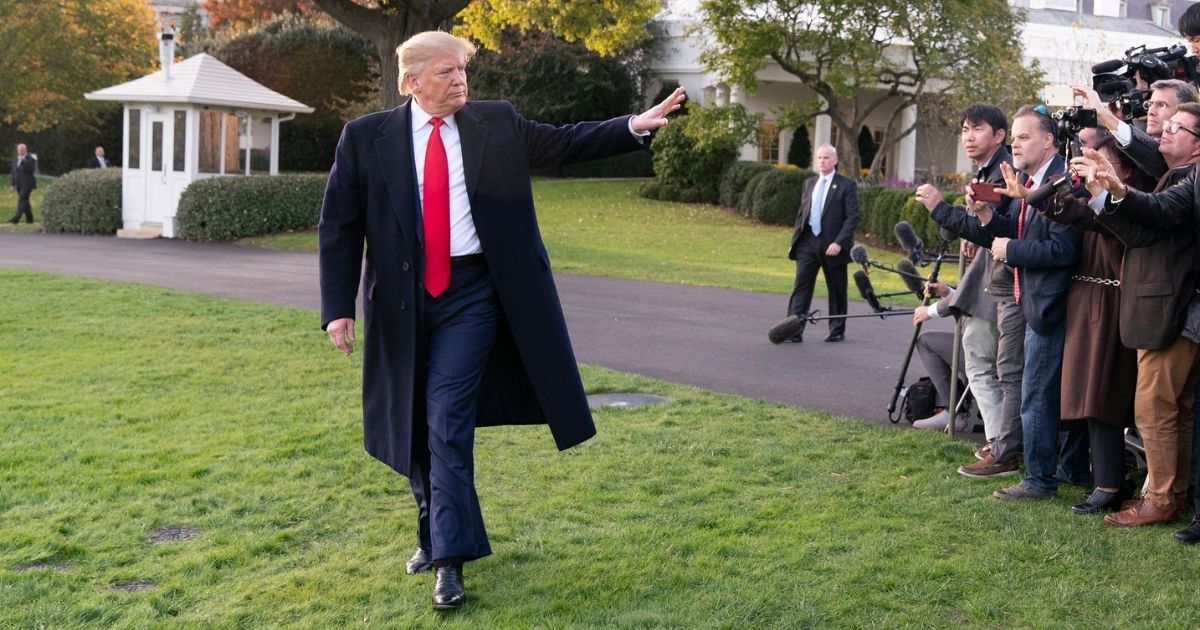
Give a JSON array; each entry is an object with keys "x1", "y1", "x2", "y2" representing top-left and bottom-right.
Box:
[{"x1": 984, "y1": 155, "x2": 1082, "y2": 335}]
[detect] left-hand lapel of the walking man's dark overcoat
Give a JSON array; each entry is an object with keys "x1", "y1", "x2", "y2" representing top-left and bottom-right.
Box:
[{"x1": 374, "y1": 103, "x2": 424, "y2": 246}]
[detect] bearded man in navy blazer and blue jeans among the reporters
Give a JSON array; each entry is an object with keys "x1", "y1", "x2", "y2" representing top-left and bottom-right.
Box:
[{"x1": 972, "y1": 106, "x2": 1090, "y2": 500}]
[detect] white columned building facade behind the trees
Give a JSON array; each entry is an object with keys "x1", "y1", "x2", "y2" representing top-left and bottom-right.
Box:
[{"x1": 648, "y1": 0, "x2": 1192, "y2": 181}]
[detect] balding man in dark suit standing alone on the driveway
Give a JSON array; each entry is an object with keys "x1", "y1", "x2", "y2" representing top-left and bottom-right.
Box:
[{"x1": 787, "y1": 144, "x2": 858, "y2": 343}]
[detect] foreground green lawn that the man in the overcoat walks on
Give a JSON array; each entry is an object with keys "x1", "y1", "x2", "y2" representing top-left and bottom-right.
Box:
[{"x1": 0, "y1": 270, "x2": 1200, "y2": 629}]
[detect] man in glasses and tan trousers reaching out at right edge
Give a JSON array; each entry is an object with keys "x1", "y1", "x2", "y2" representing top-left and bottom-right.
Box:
[{"x1": 1080, "y1": 104, "x2": 1200, "y2": 535}]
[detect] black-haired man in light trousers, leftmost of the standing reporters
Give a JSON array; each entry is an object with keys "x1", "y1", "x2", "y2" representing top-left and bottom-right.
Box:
[{"x1": 913, "y1": 103, "x2": 1025, "y2": 478}]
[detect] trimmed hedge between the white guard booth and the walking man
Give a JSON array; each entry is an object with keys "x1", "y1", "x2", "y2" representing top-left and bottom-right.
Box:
[{"x1": 175, "y1": 173, "x2": 328, "y2": 240}]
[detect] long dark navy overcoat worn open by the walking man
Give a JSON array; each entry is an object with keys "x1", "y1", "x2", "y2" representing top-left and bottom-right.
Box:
[{"x1": 318, "y1": 101, "x2": 642, "y2": 475}]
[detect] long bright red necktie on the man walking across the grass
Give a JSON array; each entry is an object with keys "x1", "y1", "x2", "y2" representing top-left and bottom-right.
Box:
[{"x1": 422, "y1": 118, "x2": 450, "y2": 298}]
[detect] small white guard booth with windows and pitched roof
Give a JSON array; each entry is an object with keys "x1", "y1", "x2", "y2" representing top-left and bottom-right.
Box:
[{"x1": 84, "y1": 34, "x2": 312, "y2": 238}]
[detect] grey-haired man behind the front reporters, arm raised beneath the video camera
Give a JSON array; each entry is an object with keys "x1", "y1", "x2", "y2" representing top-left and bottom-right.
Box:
[{"x1": 1072, "y1": 79, "x2": 1198, "y2": 179}]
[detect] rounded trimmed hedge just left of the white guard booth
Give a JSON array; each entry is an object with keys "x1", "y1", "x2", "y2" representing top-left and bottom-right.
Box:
[{"x1": 42, "y1": 168, "x2": 121, "y2": 234}]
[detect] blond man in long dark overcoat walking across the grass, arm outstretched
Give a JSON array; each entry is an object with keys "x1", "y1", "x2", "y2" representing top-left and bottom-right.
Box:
[{"x1": 319, "y1": 31, "x2": 685, "y2": 610}]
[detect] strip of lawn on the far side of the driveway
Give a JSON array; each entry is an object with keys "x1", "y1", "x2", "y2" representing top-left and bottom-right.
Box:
[{"x1": 240, "y1": 179, "x2": 958, "y2": 304}]
